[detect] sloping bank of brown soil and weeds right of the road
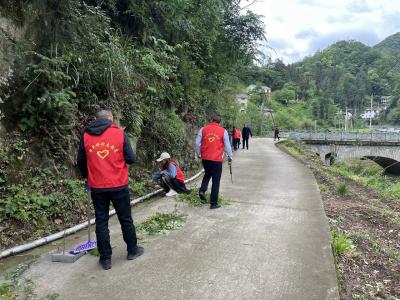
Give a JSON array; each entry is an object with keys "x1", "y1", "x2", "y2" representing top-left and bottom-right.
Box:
[{"x1": 277, "y1": 141, "x2": 400, "y2": 300}]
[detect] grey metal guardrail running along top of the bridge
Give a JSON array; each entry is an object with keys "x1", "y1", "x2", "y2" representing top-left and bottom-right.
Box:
[{"x1": 281, "y1": 131, "x2": 400, "y2": 142}]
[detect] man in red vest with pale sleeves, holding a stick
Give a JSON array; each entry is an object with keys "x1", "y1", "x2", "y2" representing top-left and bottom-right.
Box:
[{"x1": 196, "y1": 114, "x2": 232, "y2": 209}]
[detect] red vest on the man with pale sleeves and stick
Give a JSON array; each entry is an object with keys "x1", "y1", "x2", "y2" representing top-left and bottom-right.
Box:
[{"x1": 201, "y1": 122, "x2": 225, "y2": 162}]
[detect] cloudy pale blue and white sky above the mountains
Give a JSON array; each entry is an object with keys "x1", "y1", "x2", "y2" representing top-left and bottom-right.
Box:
[{"x1": 243, "y1": 0, "x2": 400, "y2": 63}]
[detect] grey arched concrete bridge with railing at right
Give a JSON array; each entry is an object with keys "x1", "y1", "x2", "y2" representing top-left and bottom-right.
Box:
[{"x1": 286, "y1": 131, "x2": 400, "y2": 175}]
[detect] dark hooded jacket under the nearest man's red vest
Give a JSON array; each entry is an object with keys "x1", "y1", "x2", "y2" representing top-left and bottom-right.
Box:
[{"x1": 77, "y1": 119, "x2": 136, "y2": 190}]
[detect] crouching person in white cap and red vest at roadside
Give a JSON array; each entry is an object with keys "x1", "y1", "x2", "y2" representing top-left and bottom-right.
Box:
[{"x1": 157, "y1": 152, "x2": 190, "y2": 197}]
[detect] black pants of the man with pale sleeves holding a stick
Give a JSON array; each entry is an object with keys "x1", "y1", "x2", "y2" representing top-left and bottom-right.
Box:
[{"x1": 200, "y1": 160, "x2": 222, "y2": 205}]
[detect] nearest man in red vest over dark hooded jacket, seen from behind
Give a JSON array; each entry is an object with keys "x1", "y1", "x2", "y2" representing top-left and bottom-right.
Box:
[{"x1": 78, "y1": 110, "x2": 143, "y2": 270}]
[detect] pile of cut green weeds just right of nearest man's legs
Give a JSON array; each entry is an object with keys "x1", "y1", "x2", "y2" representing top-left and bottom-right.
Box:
[{"x1": 136, "y1": 212, "x2": 186, "y2": 235}]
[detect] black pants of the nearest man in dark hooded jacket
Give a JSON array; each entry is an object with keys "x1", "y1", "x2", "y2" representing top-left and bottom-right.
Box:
[{"x1": 92, "y1": 188, "x2": 137, "y2": 259}]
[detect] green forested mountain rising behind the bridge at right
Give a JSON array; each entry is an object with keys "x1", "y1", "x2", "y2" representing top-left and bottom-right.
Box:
[{"x1": 243, "y1": 34, "x2": 400, "y2": 127}]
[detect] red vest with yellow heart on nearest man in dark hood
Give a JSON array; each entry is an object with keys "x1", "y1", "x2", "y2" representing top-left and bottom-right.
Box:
[{"x1": 84, "y1": 124, "x2": 128, "y2": 189}]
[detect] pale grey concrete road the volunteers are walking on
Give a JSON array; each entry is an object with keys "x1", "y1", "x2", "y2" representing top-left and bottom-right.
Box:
[{"x1": 23, "y1": 139, "x2": 339, "y2": 300}]
